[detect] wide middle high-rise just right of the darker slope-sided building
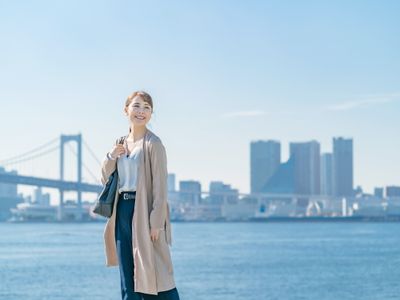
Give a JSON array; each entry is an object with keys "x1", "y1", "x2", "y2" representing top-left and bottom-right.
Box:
[{"x1": 289, "y1": 140, "x2": 320, "y2": 195}]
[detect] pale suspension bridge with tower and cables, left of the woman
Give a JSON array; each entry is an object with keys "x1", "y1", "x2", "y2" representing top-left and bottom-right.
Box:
[{"x1": 0, "y1": 134, "x2": 102, "y2": 220}]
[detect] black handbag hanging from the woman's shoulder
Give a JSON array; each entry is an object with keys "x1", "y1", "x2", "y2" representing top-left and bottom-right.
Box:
[{"x1": 92, "y1": 136, "x2": 126, "y2": 218}]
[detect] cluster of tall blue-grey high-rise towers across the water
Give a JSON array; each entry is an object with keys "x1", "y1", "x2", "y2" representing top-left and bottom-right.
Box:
[{"x1": 250, "y1": 137, "x2": 354, "y2": 197}]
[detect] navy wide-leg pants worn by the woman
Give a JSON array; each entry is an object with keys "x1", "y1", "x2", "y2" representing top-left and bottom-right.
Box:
[{"x1": 115, "y1": 192, "x2": 180, "y2": 300}]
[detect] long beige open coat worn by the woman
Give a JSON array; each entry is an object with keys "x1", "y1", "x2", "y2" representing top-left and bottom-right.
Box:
[{"x1": 101, "y1": 128, "x2": 175, "y2": 295}]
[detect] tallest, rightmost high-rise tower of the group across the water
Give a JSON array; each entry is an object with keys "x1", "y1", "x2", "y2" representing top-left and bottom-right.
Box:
[{"x1": 333, "y1": 137, "x2": 353, "y2": 197}]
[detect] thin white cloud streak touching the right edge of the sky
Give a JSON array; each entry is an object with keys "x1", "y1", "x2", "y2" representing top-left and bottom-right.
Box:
[{"x1": 324, "y1": 93, "x2": 400, "y2": 111}]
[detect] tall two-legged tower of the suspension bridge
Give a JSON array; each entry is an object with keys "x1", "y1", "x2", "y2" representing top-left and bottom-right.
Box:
[{"x1": 57, "y1": 134, "x2": 82, "y2": 221}]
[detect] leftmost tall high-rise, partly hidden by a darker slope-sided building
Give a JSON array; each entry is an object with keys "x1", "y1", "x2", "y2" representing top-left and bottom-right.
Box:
[{"x1": 250, "y1": 140, "x2": 281, "y2": 193}]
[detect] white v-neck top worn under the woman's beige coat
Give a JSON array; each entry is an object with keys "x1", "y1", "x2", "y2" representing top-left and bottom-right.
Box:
[{"x1": 117, "y1": 138, "x2": 143, "y2": 193}]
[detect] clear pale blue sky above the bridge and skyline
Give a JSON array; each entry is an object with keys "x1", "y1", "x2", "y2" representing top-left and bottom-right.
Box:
[{"x1": 0, "y1": 1, "x2": 400, "y2": 202}]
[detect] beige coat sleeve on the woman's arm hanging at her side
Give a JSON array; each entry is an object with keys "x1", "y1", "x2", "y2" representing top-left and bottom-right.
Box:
[{"x1": 150, "y1": 141, "x2": 168, "y2": 229}]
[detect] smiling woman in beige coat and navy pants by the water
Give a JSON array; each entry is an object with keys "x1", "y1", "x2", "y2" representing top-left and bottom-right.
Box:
[{"x1": 101, "y1": 91, "x2": 179, "y2": 300}]
